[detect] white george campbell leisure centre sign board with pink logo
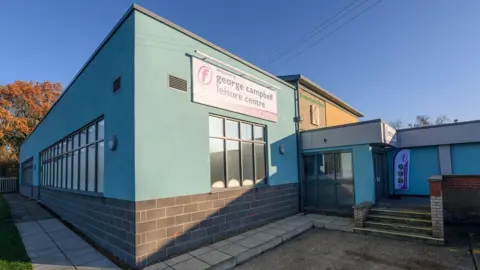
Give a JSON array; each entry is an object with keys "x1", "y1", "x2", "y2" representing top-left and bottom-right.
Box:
[{"x1": 192, "y1": 58, "x2": 277, "y2": 122}]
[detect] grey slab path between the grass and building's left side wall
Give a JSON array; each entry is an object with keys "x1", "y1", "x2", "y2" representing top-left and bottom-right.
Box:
[{"x1": 3, "y1": 194, "x2": 118, "y2": 270}]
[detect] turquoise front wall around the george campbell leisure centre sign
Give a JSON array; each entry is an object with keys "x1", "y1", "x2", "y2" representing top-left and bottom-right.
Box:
[{"x1": 134, "y1": 11, "x2": 298, "y2": 200}]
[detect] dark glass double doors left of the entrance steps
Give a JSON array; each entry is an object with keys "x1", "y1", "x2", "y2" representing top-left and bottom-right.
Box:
[{"x1": 303, "y1": 152, "x2": 355, "y2": 210}]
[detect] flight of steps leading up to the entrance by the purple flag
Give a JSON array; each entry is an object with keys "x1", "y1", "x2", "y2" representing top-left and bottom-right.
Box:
[{"x1": 355, "y1": 208, "x2": 443, "y2": 244}]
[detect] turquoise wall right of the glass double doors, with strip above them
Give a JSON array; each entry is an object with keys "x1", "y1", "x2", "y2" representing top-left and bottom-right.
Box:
[{"x1": 303, "y1": 144, "x2": 375, "y2": 203}]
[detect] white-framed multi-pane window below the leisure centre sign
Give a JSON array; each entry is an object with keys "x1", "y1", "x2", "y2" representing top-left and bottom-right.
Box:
[{"x1": 209, "y1": 116, "x2": 266, "y2": 188}]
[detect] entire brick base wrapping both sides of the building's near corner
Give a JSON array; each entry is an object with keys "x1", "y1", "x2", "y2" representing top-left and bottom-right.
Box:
[{"x1": 40, "y1": 184, "x2": 299, "y2": 268}]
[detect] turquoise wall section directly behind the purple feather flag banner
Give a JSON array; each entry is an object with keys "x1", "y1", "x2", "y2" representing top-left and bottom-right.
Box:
[{"x1": 390, "y1": 146, "x2": 440, "y2": 195}]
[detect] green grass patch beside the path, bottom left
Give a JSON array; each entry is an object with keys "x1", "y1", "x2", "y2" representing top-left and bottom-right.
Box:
[{"x1": 0, "y1": 196, "x2": 32, "y2": 270}]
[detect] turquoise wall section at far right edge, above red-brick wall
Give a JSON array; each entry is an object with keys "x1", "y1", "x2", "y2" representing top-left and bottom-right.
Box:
[{"x1": 450, "y1": 143, "x2": 480, "y2": 175}]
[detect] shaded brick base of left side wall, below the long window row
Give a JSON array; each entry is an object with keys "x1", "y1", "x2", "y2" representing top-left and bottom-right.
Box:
[{"x1": 40, "y1": 187, "x2": 136, "y2": 265}]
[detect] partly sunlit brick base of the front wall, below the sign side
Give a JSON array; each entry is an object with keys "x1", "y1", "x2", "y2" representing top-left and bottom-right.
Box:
[{"x1": 135, "y1": 184, "x2": 299, "y2": 266}]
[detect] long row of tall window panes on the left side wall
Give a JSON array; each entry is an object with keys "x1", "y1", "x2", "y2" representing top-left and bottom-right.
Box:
[{"x1": 40, "y1": 119, "x2": 105, "y2": 192}]
